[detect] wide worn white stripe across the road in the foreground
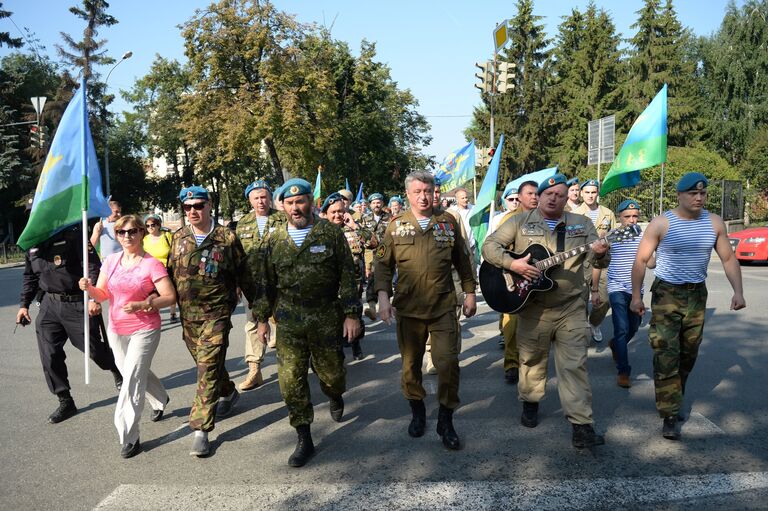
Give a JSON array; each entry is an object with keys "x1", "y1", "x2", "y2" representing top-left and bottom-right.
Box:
[{"x1": 94, "y1": 472, "x2": 768, "y2": 511}]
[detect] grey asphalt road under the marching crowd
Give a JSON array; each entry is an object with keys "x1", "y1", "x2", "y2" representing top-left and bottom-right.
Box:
[{"x1": 0, "y1": 260, "x2": 768, "y2": 510}]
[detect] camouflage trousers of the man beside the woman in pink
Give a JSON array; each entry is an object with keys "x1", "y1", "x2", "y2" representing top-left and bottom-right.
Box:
[{"x1": 181, "y1": 316, "x2": 235, "y2": 431}]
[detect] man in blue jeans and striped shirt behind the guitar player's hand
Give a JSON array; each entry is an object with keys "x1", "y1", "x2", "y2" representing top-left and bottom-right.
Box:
[{"x1": 592, "y1": 199, "x2": 656, "y2": 389}]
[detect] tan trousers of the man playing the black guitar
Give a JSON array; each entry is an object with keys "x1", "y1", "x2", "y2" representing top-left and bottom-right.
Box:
[{"x1": 517, "y1": 298, "x2": 592, "y2": 424}]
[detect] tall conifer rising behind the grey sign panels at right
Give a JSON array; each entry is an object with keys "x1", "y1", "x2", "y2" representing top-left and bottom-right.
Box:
[{"x1": 550, "y1": 3, "x2": 624, "y2": 175}]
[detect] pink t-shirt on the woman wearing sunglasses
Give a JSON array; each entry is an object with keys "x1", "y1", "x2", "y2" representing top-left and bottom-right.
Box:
[{"x1": 101, "y1": 252, "x2": 168, "y2": 335}]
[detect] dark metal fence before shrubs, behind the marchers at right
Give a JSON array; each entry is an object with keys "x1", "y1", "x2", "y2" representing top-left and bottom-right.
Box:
[{"x1": 600, "y1": 179, "x2": 744, "y2": 221}]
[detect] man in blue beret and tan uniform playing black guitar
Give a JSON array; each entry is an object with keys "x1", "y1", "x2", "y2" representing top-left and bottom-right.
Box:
[{"x1": 483, "y1": 174, "x2": 610, "y2": 449}]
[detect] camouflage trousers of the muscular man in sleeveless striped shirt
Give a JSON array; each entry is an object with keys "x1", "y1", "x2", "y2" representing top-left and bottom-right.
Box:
[{"x1": 648, "y1": 279, "x2": 707, "y2": 417}]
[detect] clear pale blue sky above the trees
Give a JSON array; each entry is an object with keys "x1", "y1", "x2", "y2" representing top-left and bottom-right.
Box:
[{"x1": 0, "y1": 0, "x2": 743, "y2": 161}]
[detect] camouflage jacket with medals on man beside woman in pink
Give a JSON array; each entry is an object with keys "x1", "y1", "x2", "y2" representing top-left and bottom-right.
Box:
[{"x1": 168, "y1": 225, "x2": 256, "y2": 321}]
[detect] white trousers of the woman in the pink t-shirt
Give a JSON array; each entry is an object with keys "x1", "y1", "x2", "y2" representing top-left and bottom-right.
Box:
[{"x1": 107, "y1": 329, "x2": 168, "y2": 445}]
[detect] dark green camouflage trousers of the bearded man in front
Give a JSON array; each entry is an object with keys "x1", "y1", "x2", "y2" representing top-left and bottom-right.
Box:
[{"x1": 275, "y1": 304, "x2": 347, "y2": 428}]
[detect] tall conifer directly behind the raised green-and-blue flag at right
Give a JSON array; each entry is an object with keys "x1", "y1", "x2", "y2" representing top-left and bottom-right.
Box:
[{"x1": 617, "y1": 0, "x2": 701, "y2": 146}]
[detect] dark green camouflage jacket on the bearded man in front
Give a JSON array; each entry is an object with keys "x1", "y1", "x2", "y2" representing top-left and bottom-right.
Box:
[{"x1": 251, "y1": 216, "x2": 361, "y2": 322}]
